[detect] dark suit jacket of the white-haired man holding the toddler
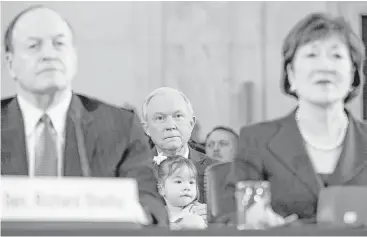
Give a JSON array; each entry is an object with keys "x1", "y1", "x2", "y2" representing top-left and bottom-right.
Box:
[{"x1": 152, "y1": 146, "x2": 216, "y2": 203}]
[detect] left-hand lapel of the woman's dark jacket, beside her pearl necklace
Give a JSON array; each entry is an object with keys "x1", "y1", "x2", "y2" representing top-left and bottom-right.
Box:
[{"x1": 268, "y1": 112, "x2": 321, "y2": 196}]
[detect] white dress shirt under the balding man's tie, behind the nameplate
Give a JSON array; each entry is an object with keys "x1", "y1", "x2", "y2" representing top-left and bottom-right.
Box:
[{"x1": 17, "y1": 91, "x2": 72, "y2": 177}]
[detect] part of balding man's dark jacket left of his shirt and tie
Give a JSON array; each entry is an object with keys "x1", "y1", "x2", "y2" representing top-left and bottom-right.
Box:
[{"x1": 1, "y1": 98, "x2": 28, "y2": 175}]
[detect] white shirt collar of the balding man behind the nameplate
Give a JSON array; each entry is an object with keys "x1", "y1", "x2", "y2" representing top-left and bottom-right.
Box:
[{"x1": 17, "y1": 91, "x2": 72, "y2": 136}]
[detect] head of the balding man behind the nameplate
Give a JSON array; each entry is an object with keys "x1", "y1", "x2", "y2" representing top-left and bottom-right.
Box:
[{"x1": 5, "y1": 6, "x2": 77, "y2": 94}]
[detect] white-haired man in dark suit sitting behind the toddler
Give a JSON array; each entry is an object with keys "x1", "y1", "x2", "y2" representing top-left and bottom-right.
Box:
[{"x1": 143, "y1": 87, "x2": 214, "y2": 206}]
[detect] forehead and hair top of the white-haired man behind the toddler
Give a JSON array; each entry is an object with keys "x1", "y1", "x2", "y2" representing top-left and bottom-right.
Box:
[{"x1": 147, "y1": 92, "x2": 193, "y2": 115}]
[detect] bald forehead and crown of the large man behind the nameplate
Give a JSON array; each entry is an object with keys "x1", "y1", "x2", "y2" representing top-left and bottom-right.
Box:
[{"x1": 13, "y1": 8, "x2": 72, "y2": 40}]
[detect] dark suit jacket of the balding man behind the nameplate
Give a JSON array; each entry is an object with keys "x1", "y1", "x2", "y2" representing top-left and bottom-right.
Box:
[{"x1": 1, "y1": 94, "x2": 168, "y2": 225}]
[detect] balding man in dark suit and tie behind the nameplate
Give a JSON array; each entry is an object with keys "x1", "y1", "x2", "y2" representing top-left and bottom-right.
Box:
[{"x1": 1, "y1": 6, "x2": 168, "y2": 225}]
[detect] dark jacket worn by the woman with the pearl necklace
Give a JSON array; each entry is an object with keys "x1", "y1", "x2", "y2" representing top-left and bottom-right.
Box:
[{"x1": 221, "y1": 109, "x2": 367, "y2": 219}]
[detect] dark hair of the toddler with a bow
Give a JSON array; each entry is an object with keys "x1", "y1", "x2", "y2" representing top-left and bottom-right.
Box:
[{"x1": 154, "y1": 155, "x2": 200, "y2": 200}]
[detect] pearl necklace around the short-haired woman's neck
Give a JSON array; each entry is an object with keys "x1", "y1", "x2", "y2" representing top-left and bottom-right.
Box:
[{"x1": 296, "y1": 110, "x2": 349, "y2": 151}]
